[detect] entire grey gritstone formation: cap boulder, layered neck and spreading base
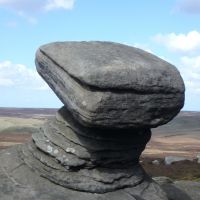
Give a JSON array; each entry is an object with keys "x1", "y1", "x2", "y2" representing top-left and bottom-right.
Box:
[{"x1": 0, "y1": 42, "x2": 184, "y2": 200}]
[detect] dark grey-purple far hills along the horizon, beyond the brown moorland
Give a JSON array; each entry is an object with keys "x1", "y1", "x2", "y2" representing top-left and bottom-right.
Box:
[{"x1": 0, "y1": 108, "x2": 200, "y2": 134}]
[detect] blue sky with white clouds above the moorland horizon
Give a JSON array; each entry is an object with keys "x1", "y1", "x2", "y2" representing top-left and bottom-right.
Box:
[{"x1": 0, "y1": 0, "x2": 200, "y2": 111}]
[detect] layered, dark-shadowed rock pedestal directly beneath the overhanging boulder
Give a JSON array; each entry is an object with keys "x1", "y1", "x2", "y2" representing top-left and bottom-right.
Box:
[{"x1": 22, "y1": 108, "x2": 151, "y2": 193}]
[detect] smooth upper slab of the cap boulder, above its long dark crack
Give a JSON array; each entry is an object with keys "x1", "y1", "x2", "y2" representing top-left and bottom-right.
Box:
[{"x1": 36, "y1": 42, "x2": 184, "y2": 93}]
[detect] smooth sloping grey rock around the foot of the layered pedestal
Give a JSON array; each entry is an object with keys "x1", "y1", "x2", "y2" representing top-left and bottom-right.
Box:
[{"x1": 0, "y1": 145, "x2": 167, "y2": 200}]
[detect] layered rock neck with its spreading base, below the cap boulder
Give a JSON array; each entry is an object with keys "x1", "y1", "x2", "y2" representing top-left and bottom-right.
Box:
[{"x1": 0, "y1": 107, "x2": 167, "y2": 200}]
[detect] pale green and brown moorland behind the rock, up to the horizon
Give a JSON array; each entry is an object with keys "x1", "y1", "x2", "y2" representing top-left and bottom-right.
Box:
[{"x1": 0, "y1": 108, "x2": 200, "y2": 158}]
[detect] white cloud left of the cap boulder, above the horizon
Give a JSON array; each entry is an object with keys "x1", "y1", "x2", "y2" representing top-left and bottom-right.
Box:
[{"x1": 0, "y1": 61, "x2": 49, "y2": 90}]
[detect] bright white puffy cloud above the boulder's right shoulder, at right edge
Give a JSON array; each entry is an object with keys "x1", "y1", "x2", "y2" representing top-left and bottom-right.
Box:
[{"x1": 154, "y1": 30, "x2": 200, "y2": 53}]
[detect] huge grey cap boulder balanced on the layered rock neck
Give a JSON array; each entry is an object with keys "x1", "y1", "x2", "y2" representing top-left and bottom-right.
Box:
[{"x1": 36, "y1": 42, "x2": 184, "y2": 128}]
